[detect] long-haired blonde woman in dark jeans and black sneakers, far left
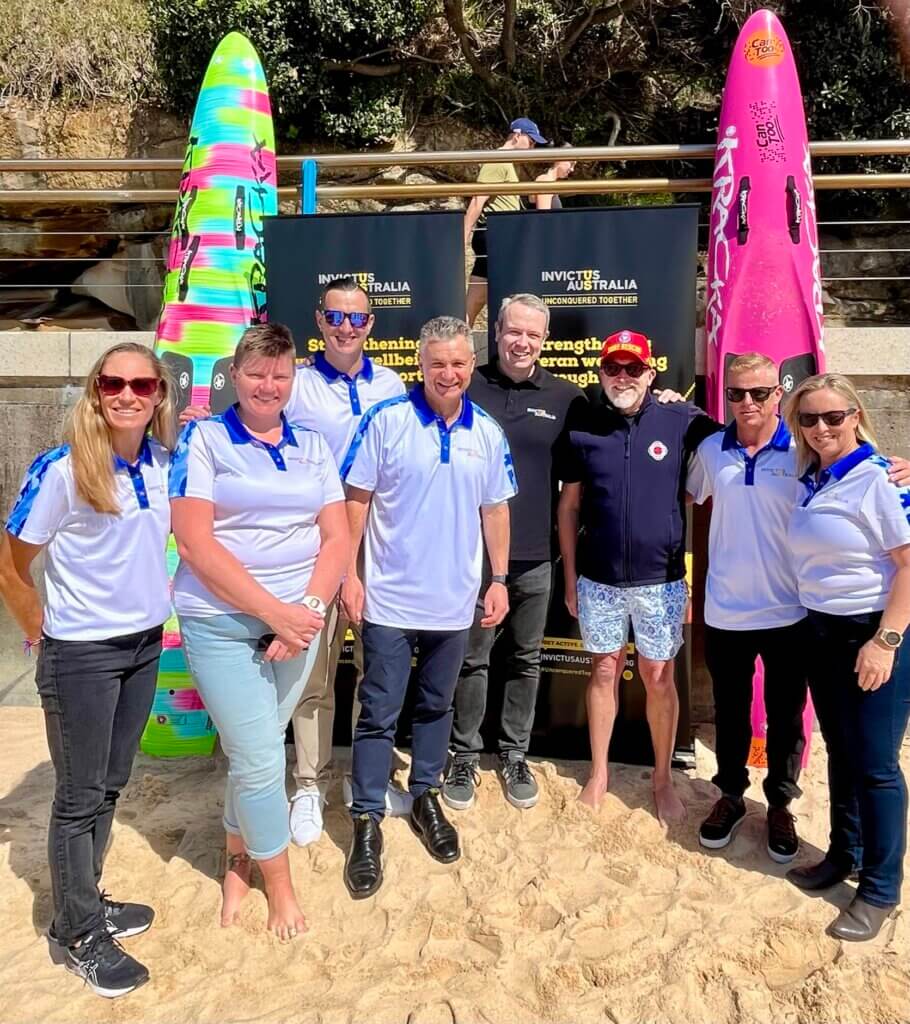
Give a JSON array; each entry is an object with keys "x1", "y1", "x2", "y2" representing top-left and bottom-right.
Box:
[{"x1": 0, "y1": 343, "x2": 176, "y2": 997}]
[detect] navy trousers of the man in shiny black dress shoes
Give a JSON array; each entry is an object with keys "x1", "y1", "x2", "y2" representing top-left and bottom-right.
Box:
[{"x1": 351, "y1": 622, "x2": 468, "y2": 820}]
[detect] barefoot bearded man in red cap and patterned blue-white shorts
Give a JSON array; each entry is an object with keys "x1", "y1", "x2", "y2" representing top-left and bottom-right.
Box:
[{"x1": 558, "y1": 331, "x2": 719, "y2": 823}]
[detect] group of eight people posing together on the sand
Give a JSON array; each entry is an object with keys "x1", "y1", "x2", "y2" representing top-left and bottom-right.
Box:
[{"x1": 0, "y1": 279, "x2": 910, "y2": 996}]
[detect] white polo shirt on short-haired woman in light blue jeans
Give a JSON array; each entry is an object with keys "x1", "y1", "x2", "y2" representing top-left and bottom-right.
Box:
[{"x1": 170, "y1": 406, "x2": 344, "y2": 617}]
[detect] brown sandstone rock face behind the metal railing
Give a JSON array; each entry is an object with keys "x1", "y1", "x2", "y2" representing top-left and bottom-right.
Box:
[{"x1": 0, "y1": 99, "x2": 910, "y2": 329}]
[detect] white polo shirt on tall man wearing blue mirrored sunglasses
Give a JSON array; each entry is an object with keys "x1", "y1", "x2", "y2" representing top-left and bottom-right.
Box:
[{"x1": 285, "y1": 352, "x2": 404, "y2": 466}]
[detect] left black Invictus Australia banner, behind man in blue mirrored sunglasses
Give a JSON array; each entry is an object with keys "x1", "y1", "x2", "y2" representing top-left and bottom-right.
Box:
[{"x1": 265, "y1": 210, "x2": 465, "y2": 384}]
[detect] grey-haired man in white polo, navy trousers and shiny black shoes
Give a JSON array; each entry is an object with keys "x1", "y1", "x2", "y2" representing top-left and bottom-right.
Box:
[{"x1": 342, "y1": 316, "x2": 517, "y2": 898}]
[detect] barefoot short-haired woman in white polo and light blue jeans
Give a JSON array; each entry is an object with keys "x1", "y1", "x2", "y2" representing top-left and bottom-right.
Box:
[{"x1": 171, "y1": 324, "x2": 350, "y2": 940}]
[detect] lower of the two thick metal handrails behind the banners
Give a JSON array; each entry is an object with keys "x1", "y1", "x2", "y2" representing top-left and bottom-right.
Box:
[{"x1": 0, "y1": 174, "x2": 910, "y2": 205}]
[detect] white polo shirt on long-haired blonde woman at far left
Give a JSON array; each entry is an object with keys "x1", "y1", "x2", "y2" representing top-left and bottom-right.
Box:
[{"x1": 6, "y1": 439, "x2": 171, "y2": 640}]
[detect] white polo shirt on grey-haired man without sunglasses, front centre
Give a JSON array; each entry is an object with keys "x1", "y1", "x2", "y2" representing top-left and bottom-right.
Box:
[{"x1": 342, "y1": 385, "x2": 518, "y2": 631}]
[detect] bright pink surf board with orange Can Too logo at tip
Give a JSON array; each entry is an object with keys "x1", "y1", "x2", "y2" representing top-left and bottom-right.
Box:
[{"x1": 705, "y1": 10, "x2": 824, "y2": 767}]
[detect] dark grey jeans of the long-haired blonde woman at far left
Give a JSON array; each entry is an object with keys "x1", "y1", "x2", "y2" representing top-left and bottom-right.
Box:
[{"x1": 35, "y1": 626, "x2": 162, "y2": 945}]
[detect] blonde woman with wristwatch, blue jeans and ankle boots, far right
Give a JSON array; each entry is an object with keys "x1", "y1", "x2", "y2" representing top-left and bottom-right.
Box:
[{"x1": 786, "y1": 374, "x2": 910, "y2": 941}]
